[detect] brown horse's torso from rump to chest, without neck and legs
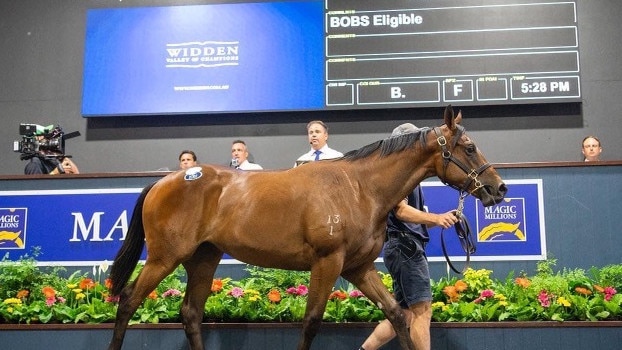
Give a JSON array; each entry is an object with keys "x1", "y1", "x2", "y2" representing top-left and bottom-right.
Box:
[{"x1": 144, "y1": 164, "x2": 382, "y2": 269}]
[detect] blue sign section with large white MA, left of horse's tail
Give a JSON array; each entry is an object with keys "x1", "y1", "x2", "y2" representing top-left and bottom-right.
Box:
[{"x1": 0, "y1": 188, "x2": 144, "y2": 266}]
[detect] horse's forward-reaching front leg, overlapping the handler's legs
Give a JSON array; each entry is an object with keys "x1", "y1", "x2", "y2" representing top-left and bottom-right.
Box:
[{"x1": 342, "y1": 262, "x2": 415, "y2": 350}]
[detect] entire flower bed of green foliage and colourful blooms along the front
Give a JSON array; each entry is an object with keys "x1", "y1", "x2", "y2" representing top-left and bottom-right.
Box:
[{"x1": 0, "y1": 250, "x2": 622, "y2": 324}]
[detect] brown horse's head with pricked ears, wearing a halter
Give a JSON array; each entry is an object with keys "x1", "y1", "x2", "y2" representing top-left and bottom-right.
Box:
[{"x1": 434, "y1": 106, "x2": 507, "y2": 206}]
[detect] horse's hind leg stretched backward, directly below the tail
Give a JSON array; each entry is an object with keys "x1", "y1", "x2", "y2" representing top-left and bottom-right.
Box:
[{"x1": 108, "y1": 258, "x2": 177, "y2": 350}]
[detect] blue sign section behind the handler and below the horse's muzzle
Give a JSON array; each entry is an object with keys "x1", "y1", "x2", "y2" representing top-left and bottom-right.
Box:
[{"x1": 423, "y1": 179, "x2": 546, "y2": 261}]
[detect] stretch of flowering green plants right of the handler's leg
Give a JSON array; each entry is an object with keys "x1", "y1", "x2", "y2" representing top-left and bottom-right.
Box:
[{"x1": 432, "y1": 266, "x2": 622, "y2": 322}]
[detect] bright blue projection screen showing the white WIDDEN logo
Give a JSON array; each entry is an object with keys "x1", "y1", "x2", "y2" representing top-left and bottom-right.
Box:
[{"x1": 82, "y1": 1, "x2": 324, "y2": 117}]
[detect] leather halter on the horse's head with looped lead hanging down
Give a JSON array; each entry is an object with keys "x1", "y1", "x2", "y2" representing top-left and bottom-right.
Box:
[{"x1": 434, "y1": 127, "x2": 490, "y2": 274}]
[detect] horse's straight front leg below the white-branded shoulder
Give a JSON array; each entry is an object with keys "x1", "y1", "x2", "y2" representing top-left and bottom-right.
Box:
[{"x1": 298, "y1": 256, "x2": 343, "y2": 350}]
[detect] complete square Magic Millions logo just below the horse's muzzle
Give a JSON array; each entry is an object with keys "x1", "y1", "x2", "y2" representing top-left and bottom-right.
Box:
[{"x1": 477, "y1": 198, "x2": 527, "y2": 242}]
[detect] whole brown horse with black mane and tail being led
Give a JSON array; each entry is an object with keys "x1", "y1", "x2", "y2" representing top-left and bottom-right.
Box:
[{"x1": 109, "y1": 106, "x2": 506, "y2": 350}]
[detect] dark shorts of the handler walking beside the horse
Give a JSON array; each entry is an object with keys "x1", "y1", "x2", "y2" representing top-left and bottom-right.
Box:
[{"x1": 384, "y1": 233, "x2": 432, "y2": 308}]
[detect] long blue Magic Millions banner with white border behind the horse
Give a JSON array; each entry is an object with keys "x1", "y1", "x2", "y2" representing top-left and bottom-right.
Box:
[{"x1": 0, "y1": 179, "x2": 546, "y2": 266}]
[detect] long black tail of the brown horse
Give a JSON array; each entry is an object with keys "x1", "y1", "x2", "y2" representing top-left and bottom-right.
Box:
[{"x1": 110, "y1": 182, "x2": 156, "y2": 295}]
